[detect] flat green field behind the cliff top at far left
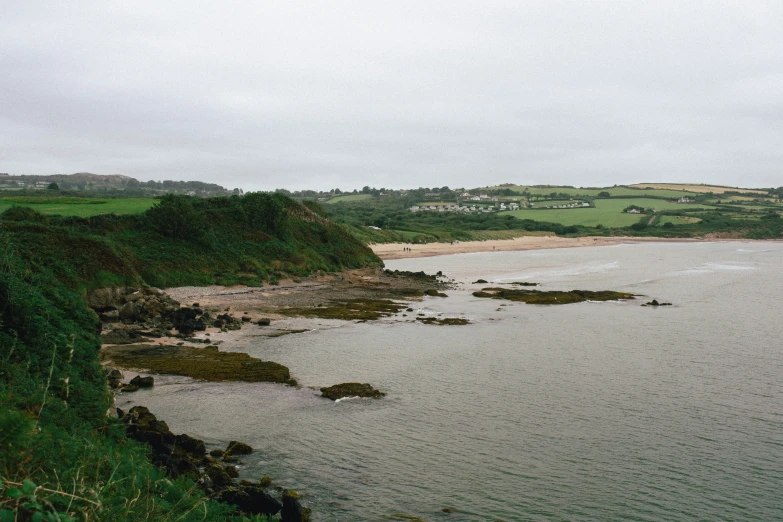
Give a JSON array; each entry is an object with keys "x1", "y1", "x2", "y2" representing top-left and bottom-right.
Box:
[{"x1": 0, "y1": 196, "x2": 158, "y2": 217}]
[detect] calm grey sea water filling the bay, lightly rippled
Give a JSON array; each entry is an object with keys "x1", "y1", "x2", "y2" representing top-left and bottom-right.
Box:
[{"x1": 122, "y1": 242, "x2": 783, "y2": 521}]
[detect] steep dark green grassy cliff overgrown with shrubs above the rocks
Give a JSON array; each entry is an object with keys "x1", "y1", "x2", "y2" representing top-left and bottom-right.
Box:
[{"x1": 0, "y1": 194, "x2": 380, "y2": 520}]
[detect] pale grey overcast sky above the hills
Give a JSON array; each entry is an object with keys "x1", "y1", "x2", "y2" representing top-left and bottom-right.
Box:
[{"x1": 0, "y1": 0, "x2": 783, "y2": 190}]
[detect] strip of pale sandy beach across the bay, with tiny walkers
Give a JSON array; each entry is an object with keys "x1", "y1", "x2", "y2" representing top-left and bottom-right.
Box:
[{"x1": 370, "y1": 236, "x2": 704, "y2": 259}]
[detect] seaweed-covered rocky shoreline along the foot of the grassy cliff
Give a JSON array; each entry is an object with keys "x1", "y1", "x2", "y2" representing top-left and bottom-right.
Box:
[{"x1": 95, "y1": 270, "x2": 460, "y2": 522}]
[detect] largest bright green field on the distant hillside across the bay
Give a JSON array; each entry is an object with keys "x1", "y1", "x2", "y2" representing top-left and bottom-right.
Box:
[{"x1": 505, "y1": 198, "x2": 712, "y2": 228}]
